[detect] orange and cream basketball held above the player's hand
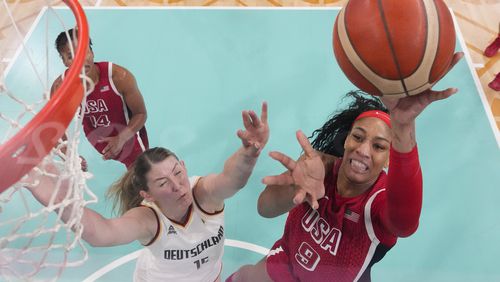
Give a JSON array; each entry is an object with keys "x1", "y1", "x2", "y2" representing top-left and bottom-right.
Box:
[{"x1": 333, "y1": 0, "x2": 455, "y2": 97}]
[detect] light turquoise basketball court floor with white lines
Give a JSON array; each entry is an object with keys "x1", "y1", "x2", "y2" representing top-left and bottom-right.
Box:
[{"x1": 0, "y1": 4, "x2": 500, "y2": 281}]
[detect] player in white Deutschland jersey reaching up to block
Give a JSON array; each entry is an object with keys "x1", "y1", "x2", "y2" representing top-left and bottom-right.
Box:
[{"x1": 25, "y1": 103, "x2": 269, "y2": 282}]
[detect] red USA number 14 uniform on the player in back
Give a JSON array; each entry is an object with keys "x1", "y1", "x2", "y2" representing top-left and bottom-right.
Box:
[{"x1": 79, "y1": 62, "x2": 149, "y2": 167}]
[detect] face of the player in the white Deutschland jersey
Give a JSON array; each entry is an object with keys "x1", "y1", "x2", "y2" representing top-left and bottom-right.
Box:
[{"x1": 146, "y1": 156, "x2": 193, "y2": 209}]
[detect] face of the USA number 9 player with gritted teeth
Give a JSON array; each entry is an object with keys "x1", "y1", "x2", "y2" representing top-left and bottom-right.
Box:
[{"x1": 341, "y1": 117, "x2": 392, "y2": 184}]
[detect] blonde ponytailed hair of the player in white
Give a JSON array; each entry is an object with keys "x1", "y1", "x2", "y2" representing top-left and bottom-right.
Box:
[{"x1": 106, "y1": 147, "x2": 178, "y2": 215}]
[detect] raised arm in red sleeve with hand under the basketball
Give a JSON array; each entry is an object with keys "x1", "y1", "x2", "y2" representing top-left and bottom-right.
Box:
[{"x1": 381, "y1": 52, "x2": 463, "y2": 237}]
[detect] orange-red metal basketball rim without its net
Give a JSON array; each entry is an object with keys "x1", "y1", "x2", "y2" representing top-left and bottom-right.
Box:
[{"x1": 0, "y1": 0, "x2": 89, "y2": 193}]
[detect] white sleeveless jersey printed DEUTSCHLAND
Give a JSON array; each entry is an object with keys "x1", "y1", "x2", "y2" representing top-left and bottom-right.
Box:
[{"x1": 134, "y1": 177, "x2": 224, "y2": 282}]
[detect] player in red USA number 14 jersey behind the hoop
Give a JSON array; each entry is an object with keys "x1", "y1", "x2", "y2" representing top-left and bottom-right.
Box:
[{"x1": 51, "y1": 29, "x2": 149, "y2": 169}]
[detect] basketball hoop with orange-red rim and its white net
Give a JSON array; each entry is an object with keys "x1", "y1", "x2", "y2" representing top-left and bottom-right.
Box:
[{"x1": 0, "y1": 0, "x2": 97, "y2": 281}]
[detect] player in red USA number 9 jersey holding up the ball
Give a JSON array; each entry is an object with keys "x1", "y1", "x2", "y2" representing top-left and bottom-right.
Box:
[{"x1": 226, "y1": 53, "x2": 463, "y2": 281}]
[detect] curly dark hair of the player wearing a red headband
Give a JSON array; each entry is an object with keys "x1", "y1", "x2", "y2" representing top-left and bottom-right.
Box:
[{"x1": 309, "y1": 90, "x2": 389, "y2": 157}]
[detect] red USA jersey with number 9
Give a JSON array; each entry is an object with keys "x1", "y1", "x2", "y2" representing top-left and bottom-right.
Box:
[{"x1": 266, "y1": 159, "x2": 397, "y2": 281}]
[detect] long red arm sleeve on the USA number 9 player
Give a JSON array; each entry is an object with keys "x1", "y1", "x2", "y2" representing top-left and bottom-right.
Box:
[{"x1": 379, "y1": 146, "x2": 422, "y2": 237}]
